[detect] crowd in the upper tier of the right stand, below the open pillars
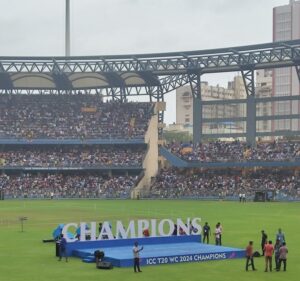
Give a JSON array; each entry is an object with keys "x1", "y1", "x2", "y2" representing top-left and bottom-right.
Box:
[{"x1": 167, "y1": 141, "x2": 300, "y2": 162}]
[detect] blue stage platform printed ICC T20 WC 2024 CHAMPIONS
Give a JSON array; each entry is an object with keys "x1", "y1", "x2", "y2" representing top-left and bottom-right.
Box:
[{"x1": 68, "y1": 235, "x2": 245, "y2": 267}]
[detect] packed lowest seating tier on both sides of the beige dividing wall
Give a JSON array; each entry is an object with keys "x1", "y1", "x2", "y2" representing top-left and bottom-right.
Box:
[{"x1": 0, "y1": 167, "x2": 300, "y2": 201}]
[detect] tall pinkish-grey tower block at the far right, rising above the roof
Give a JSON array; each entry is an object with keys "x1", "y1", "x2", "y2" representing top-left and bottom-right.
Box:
[{"x1": 272, "y1": 0, "x2": 300, "y2": 131}]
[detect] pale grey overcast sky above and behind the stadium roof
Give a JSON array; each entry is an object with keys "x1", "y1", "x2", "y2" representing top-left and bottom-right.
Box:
[{"x1": 0, "y1": 0, "x2": 289, "y2": 123}]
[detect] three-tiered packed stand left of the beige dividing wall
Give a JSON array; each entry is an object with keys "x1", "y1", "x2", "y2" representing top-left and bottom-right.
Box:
[{"x1": 0, "y1": 94, "x2": 158, "y2": 199}]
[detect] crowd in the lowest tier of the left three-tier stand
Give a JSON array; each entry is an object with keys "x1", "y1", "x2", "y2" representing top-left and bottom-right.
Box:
[{"x1": 0, "y1": 173, "x2": 137, "y2": 199}]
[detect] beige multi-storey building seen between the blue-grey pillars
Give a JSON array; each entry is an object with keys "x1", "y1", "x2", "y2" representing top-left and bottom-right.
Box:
[{"x1": 176, "y1": 76, "x2": 246, "y2": 134}]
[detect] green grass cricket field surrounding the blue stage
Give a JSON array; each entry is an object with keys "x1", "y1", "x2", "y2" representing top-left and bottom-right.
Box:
[{"x1": 0, "y1": 200, "x2": 300, "y2": 281}]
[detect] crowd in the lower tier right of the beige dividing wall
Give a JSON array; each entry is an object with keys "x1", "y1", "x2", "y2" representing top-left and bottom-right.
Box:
[{"x1": 150, "y1": 169, "x2": 300, "y2": 199}]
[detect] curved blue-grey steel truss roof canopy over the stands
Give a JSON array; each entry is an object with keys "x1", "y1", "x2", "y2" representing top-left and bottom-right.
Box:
[{"x1": 0, "y1": 40, "x2": 300, "y2": 94}]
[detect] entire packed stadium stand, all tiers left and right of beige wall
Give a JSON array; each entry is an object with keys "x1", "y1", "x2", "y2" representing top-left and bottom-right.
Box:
[{"x1": 0, "y1": 94, "x2": 300, "y2": 200}]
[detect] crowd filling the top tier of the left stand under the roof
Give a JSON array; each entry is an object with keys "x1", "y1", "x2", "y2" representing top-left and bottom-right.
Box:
[{"x1": 0, "y1": 94, "x2": 153, "y2": 139}]
